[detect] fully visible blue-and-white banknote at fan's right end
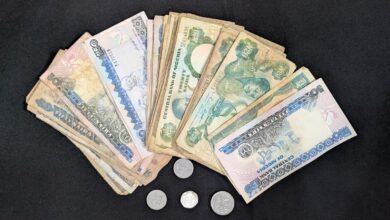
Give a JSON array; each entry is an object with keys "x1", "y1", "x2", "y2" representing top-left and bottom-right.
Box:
[{"x1": 215, "y1": 79, "x2": 356, "y2": 203}]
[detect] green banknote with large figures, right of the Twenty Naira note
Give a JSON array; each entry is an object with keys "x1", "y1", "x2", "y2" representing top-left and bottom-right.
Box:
[{"x1": 176, "y1": 32, "x2": 295, "y2": 170}]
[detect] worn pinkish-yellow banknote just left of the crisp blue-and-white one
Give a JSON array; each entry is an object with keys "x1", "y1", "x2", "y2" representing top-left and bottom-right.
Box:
[{"x1": 40, "y1": 33, "x2": 141, "y2": 168}]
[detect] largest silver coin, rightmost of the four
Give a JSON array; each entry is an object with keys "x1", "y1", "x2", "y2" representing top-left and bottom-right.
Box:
[{"x1": 210, "y1": 191, "x2": 234, "y2": 215}]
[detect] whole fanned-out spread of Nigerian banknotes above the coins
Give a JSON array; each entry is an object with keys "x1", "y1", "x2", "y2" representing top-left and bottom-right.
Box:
[{"x1": 26, "y1": 12, "x2": 356, "y2": 202}]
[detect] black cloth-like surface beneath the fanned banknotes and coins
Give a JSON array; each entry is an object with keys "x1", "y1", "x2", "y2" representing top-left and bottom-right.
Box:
[{"x1": 0, "y1": 0, "x2": 390, "y2": 219}]
